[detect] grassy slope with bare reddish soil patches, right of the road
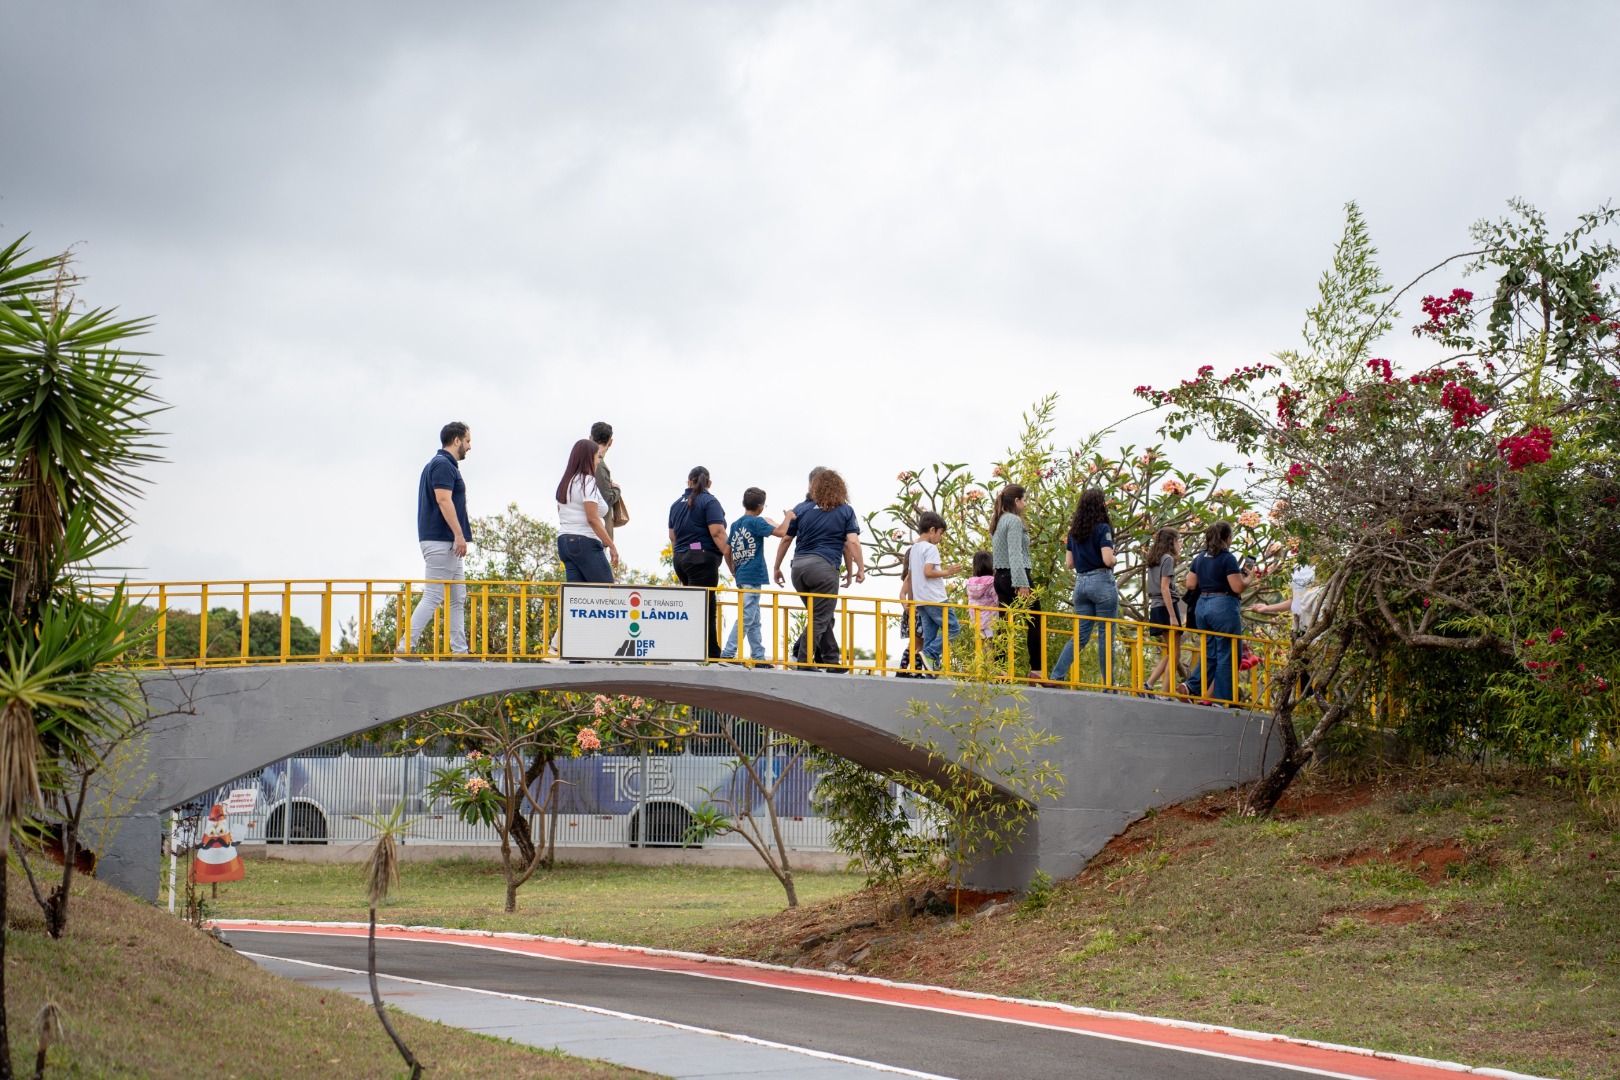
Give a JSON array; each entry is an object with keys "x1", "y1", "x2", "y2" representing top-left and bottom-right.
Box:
[{"x1": 679, "y1": 776, "x2": 1620, "y2": 1077}]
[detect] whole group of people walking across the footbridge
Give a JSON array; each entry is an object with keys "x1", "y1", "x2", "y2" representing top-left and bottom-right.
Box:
[{"x1": 399, "y1": 421, "x2": 1312, "y2": 701}]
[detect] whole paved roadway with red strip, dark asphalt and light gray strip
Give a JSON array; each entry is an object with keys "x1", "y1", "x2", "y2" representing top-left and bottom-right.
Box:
[{"x1": 222, "y1": 923, "x2": 1542, "y2": 1080}]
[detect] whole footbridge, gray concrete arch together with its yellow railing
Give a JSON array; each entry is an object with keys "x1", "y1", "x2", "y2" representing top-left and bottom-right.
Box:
[{"x1": 99, "y1": 581, "x2": 1277, "y2": 899}]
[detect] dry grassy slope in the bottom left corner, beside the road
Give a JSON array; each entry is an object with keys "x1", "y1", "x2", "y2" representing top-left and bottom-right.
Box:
[{"x1": 6, "y1": 873, "x2": 646, "y2": 1080}]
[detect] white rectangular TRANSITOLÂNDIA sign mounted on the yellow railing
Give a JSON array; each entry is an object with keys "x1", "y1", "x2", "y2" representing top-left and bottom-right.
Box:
[{"x1": 561, "y1": 585, "x2": 708, "y2": 662}]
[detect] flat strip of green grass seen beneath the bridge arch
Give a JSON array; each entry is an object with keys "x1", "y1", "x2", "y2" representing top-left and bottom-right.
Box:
[{"x1": 207, "y1": 860, "x2": 860, "y2": 946}]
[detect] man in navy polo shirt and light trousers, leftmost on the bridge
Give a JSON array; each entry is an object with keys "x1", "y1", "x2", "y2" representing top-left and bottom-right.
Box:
[{"x1": 399, "y1": 421, "x2": 473, "y2": 654}]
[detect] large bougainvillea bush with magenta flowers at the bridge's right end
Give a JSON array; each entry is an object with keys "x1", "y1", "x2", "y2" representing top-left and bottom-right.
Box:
[{"x1": 1137, "y1": 202, "x2": 1620, "y2": 810}]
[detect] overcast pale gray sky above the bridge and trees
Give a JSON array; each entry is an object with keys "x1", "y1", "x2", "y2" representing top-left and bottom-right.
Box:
[{"x1": 0, "y1": 0, "x2": 1620, "y2": 595}]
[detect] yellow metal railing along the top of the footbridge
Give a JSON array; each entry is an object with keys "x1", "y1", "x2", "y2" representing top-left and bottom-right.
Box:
[{"x1": 96, "y1": 578, "x2": 1288, "y2": 708}]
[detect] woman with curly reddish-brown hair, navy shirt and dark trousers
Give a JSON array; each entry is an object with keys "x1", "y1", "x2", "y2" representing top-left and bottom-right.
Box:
[{"x1": 776, "y1": 466, "x2": 867, "y2": 670}]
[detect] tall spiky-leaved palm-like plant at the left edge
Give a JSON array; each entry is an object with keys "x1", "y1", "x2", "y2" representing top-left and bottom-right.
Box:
[{"x1": 0, "y1": 240, "x2": 160, "y2": 1080}]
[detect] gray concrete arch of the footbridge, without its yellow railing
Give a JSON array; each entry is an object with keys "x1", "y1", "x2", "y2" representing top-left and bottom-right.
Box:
[{"x1": 97, "y1": 662, "x2": 1277, "y2": 900}]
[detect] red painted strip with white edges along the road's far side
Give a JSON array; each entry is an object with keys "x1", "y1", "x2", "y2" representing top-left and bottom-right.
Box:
[{"x1": 214, "y1": 920, "x2": 1537, "y2": 1080}]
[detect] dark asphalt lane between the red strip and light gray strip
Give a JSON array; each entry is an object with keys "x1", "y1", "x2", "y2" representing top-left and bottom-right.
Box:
[{"x1": 227, "y1": 928, "x2": 1332, "y2": 1080}]
